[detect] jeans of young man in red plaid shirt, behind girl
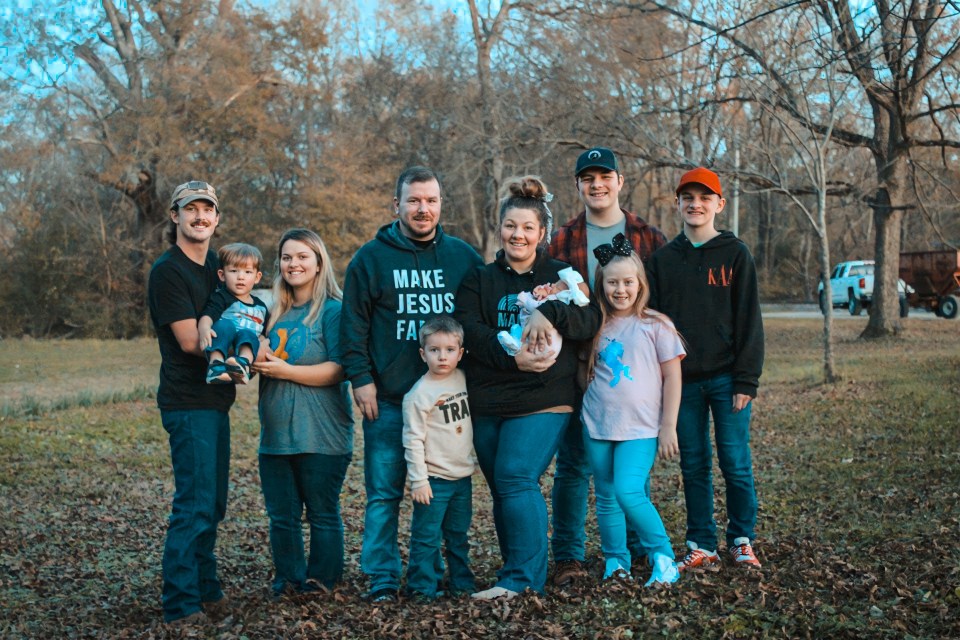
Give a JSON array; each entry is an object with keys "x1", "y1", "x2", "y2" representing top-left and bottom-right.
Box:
[{"x1": 550, "y1": 402, "x2": 650, "y2": 562}]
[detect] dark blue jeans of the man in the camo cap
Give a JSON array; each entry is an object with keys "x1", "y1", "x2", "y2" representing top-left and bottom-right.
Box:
[{"x1": 160, "y1": 409, "x2": 230, "y2": 622}]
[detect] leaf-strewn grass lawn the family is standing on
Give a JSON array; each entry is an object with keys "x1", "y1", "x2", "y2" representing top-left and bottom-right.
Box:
[{"x1": 0, "y1": 319, "x2": 960, "y2": 640}]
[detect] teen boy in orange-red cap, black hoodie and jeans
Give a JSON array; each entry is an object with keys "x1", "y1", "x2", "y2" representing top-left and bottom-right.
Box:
[{"x1": 647, "y1": 167, "x2": 763, "y2": 571}]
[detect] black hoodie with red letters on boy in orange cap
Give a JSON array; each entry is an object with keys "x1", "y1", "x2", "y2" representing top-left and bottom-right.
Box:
[{"x1": 647, "y1": 231, "x2": 763, "y2": 398}]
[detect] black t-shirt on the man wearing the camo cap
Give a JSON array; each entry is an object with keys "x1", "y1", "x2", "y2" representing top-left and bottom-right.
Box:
[{"x1": 147, "y1": 245, "x2": 237, "y2": 411}]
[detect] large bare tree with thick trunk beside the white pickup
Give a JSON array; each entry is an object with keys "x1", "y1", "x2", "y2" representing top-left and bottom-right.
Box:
[{"x1": 639, "y1": 0, "x2": 960, "y2": 338}]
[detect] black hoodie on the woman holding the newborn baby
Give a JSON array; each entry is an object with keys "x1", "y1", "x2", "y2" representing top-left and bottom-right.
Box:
[{"x1": 454, "y1": 249, "x2": 600, "y2": 416}]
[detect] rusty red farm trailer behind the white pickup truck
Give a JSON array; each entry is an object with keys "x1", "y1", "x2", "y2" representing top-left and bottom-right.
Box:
[{"x1": 900, "y1": 249, "x2": 960, "y2": 318}]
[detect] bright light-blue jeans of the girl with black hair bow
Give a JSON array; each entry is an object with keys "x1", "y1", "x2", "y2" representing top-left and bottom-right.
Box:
[{"x1": 583, "y1": 430, "x2": 674, "y2": 570}]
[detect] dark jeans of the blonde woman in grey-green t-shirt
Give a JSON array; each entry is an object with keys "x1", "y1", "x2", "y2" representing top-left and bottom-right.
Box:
[{"x1": 260, "y1": 453, "x2": 350, "y2": 594}]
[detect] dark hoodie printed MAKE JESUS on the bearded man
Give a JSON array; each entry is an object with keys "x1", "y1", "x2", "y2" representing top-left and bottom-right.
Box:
[{"x1": 340, "y1": 221, "x2": 483, "y2": 405}]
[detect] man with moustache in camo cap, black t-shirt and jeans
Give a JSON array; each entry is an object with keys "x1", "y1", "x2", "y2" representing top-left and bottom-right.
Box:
[{"x1": 147, "y1": 180, "x2": 236, "y2": 626}]
